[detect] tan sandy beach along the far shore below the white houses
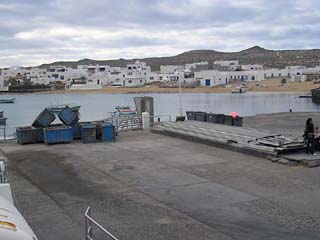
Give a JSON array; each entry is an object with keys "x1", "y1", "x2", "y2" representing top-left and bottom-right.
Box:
[{"x1": 31, "y1": 79, "x2": 319, "y2": 94}]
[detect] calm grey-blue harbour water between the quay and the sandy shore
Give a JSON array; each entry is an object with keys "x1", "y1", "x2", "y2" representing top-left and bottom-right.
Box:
[{"x1": 0, "y1": 93, "x2": 320, "y2": 135}]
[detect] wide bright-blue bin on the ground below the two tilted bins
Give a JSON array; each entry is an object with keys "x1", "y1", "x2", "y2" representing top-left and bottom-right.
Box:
[{"x1": 44, "y1": 126, "x2": 73, "y2": 144}]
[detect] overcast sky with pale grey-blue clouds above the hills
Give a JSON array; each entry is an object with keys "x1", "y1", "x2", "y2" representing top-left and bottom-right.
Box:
[{"x1": 0, "y1": 0, "x2": 320, "y2": 67}]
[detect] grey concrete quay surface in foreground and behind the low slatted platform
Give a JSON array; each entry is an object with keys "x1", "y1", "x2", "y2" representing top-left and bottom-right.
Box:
[{"x1": 0, "y1": 114, "x2": 320, "y2": 240}]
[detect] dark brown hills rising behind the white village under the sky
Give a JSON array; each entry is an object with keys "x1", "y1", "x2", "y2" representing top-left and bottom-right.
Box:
[{"x1": 39, "y1": 46, "x2": 320, "y2": 71}]
